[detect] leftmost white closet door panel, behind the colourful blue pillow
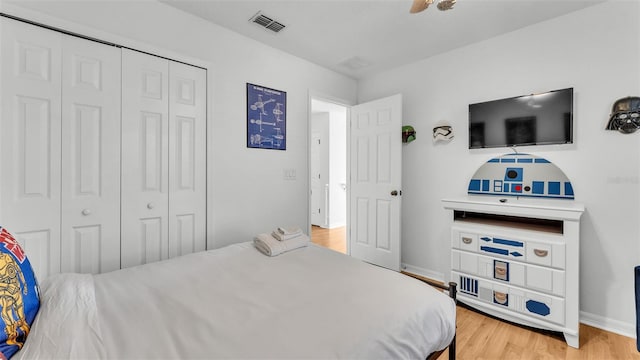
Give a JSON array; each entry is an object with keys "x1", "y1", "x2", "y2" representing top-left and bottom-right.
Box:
[{"x1": 0, "y1": 18, "x2": 61, "y2": 280}]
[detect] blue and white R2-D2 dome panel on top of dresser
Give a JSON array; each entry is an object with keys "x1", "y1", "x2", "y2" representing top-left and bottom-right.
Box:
[{"x1": 468, "y1": 154, "x2": 574, "y2": 199}]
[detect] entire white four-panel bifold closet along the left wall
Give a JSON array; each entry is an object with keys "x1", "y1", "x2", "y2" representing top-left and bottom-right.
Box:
[{"x1": 0, "y1": 18, "x2": 206, "y2": 281}]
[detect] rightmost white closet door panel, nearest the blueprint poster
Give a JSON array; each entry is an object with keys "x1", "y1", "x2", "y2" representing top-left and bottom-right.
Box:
[{"x1": 169, "y1": 61, "x2": 207, "y2": 257}]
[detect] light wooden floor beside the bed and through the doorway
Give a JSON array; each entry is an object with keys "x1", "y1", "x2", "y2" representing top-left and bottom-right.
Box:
[{"x1": 311, "y1": 226, "x2": 640, "y2": 360}]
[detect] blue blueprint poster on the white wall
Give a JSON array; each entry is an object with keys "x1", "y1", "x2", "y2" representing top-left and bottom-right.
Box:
[{"x1": 247, "y1": 83, "x2": 287, "y2": 150}]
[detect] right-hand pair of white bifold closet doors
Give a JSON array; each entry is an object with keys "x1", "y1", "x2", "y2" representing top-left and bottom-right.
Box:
[{"x1": 122, "y1": 49, "x2": 206, "y2": 267}]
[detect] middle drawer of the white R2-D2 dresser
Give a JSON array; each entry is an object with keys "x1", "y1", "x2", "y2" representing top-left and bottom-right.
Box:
[{"x1": 451, "y1": 250, "x2": 565, "y2": 296}]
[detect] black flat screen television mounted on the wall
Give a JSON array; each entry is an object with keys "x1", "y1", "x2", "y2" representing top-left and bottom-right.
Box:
[{"x1": 469, "y1": 88, "x2": 573, "y2": 149}]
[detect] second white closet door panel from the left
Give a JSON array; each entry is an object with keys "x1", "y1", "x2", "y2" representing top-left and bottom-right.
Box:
[{"x1": 61, "y1": 36, "x2": 121, "y2": 274}]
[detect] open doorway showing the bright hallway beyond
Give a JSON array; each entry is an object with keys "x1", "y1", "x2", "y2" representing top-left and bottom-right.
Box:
[{"x1": 309, "y1": 97, "x2": 348, "y2": 254}]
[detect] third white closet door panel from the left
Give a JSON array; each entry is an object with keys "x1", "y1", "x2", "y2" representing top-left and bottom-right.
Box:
[{"x1": 121, "y1": 49, "x2": 169, "y2": 268}]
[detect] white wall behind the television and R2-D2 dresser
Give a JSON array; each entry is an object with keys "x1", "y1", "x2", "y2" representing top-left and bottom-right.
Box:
[{"x1": 358, "y1": 1, "x2": 640, "y2": 336}]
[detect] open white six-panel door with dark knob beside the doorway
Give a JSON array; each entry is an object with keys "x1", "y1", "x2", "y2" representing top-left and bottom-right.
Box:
[{"x1": 349, "y1": 95, "x2": 402, "y2": 271}]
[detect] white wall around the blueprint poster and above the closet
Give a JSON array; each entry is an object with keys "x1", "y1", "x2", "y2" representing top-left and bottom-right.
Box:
[{"x1": 2, "y1": 1, "x2": 356, "y2": 248}]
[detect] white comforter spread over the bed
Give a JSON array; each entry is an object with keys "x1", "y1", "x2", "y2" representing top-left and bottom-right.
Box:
[{"x1": 15, "y1": 243, "x2": 455, "y2": 359}]
